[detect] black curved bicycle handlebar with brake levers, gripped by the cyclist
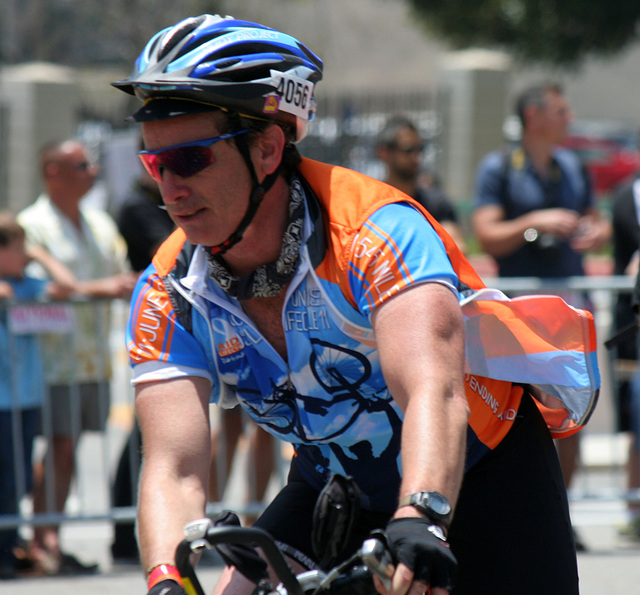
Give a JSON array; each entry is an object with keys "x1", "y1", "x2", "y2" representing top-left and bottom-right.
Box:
[{"x1": 176, "y1": 518, "x2": 395, "y2": 595}]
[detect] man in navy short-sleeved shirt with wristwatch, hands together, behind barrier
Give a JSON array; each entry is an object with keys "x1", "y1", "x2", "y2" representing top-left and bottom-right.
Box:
[{"x1": 472, "y1": 84, "x2": 611, "y2": 549}]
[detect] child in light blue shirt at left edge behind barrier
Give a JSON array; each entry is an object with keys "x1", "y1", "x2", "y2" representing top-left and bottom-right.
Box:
[{"x1": 0, "y1": 212, "x2": 74, "y2": 579}]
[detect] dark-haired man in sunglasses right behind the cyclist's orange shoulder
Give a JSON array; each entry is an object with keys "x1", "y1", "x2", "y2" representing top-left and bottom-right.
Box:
[{"x1": 376, "y1": 116, "x2": 465, "y2": 252}]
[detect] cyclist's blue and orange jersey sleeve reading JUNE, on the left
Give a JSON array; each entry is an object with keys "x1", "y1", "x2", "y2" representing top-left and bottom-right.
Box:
[{"x1": 126, "y1": 266, "x2": 214, "y2": 384}]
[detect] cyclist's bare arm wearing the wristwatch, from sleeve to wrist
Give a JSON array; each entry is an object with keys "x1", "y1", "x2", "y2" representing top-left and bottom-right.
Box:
[{"x1": 373, "y1": 283, "x2": 469, "y2": 516}]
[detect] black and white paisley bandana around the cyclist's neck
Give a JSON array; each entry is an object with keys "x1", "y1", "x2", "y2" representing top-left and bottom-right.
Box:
[{"x1": 207, "y1": 176, "x2": 304, "y2": 300}]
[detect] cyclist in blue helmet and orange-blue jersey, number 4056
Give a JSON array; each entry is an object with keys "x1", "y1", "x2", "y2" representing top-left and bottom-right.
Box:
[{"x1": 114, "y1": 15, "x2": 596, "y2": 595}]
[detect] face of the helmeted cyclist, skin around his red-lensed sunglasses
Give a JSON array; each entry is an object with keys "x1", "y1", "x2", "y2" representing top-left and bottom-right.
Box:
[{"x1": 142, "y1": 113, "x2": 251, "y2": 246}]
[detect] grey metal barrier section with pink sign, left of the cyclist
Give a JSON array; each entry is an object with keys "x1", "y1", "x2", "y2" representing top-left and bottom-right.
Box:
[{"x1": 0, "y1": 300, "x2": 133, "y2": 527}]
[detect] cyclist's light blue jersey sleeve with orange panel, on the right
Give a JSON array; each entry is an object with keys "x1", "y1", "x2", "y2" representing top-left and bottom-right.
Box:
[{"x1": 348, "y1": 203, "x2": 458, "y2": 316}]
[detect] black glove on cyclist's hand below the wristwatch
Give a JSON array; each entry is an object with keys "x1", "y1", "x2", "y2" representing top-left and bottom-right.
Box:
[{"x1": 386, "y1": 518, "x2": 458, "y2": 590}]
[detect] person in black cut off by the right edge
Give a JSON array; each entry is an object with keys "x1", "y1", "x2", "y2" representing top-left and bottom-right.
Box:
[{"x1": 612, "y1": 177, "x2": 640, "y2": 540}]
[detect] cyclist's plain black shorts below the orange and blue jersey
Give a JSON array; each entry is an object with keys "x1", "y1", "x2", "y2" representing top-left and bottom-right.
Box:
[{"x1": 256, "y1": 394, "x2": 578, "y2": 595}]
